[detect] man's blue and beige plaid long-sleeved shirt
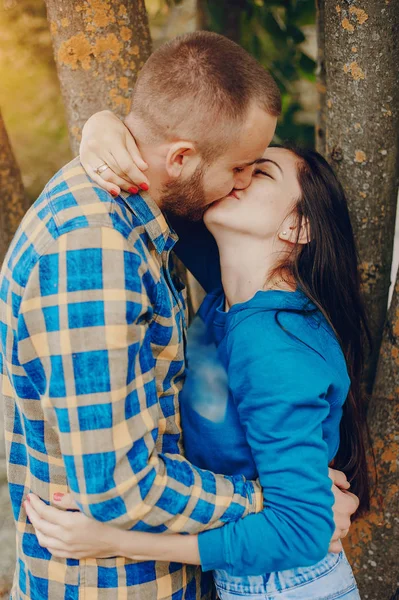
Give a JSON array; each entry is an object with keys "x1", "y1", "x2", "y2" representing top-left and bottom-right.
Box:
[{"x1": 0, "y1": 159, "x2": 261, "y2": 600}]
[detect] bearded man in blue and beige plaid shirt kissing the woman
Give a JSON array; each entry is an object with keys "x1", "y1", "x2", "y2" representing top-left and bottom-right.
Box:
[{"x1": 0, "y1": 33, "x2": 356, "y2": 600}]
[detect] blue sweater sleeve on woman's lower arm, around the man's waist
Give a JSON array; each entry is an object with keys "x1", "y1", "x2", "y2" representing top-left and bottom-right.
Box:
[{"x1": 199, "y1": 312, "x2": 334, "y2": 576}]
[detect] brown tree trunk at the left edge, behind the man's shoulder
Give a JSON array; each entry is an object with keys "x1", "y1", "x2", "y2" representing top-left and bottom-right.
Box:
[{"x1": 0, "y1": 113, "x2": 29, "y2": 264}]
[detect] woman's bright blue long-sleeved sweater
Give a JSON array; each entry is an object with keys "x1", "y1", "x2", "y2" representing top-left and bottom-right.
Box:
[{"x1": 181, "y1": 291, "x2": 349, "y2": 576}]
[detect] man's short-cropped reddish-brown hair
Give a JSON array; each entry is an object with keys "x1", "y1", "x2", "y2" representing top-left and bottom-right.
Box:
[{"x1": 132, "y1": 31, "x2": 281, "y2": 158}]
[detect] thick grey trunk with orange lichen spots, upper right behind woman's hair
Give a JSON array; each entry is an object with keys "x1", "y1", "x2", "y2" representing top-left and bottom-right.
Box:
[{"x1": 318, "y1": 0, "x2": 399, "y2": 390}]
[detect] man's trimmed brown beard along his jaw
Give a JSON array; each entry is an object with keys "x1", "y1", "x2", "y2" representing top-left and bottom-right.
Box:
[{"x1": 160, "y1": 165, "x2": 207, "y2": 221}]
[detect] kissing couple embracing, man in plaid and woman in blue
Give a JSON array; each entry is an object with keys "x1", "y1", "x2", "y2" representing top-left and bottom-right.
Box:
[{"x1": 0, "y1": 32, "x2": 368, "y2": 600}]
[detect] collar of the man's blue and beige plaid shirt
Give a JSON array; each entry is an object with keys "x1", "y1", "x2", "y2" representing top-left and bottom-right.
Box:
[{"x1": 120, "y1": 190, "x2": 179, "y2": 254}]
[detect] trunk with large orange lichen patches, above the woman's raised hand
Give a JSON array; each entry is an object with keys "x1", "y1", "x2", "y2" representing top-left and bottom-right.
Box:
[{"x1": 46, "y1": 0, "x2": 151, "y2": 152}]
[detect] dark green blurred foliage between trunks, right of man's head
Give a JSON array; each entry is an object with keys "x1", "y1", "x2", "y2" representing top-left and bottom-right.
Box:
[{"x1": 202, "y1": 0, "x2": 316, "y2": 147}]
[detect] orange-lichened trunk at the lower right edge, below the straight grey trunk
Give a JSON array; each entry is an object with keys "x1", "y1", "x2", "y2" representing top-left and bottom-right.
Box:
[{"x1": 347, "y1": 277, "x2": 399, "y2": 600}]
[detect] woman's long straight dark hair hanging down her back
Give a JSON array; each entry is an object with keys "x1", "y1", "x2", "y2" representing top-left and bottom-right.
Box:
[{"x1": 274, "y1": 146, "x2": 370, "y2": 512}]
